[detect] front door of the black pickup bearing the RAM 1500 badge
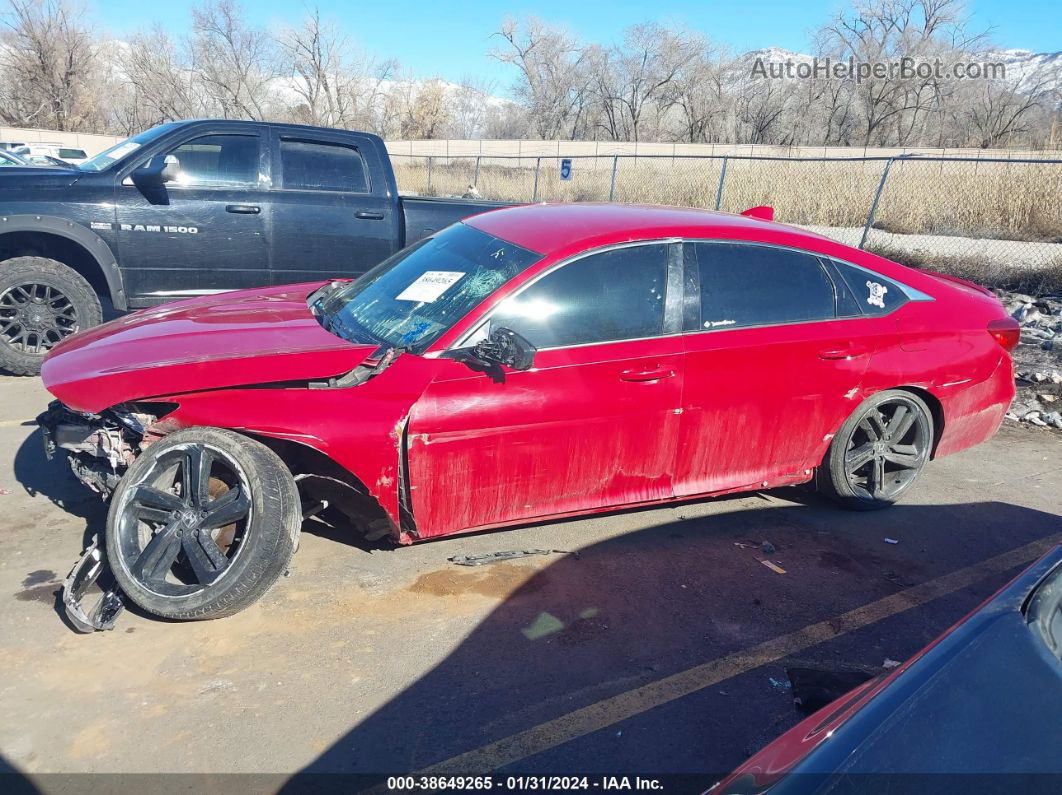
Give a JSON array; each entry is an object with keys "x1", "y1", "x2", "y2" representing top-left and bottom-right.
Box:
[{"x1": 115, "y1": 123, "x2": 270, "y2": 305}]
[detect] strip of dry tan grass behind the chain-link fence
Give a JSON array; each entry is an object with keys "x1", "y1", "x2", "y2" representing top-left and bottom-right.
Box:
[{"x1": 395, "y1": 157, "x2": 1062, "y2": 242}]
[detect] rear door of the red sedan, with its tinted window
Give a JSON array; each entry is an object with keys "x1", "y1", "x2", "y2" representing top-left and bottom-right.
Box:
[{"x1": 675, "y1": 242, "x2": 876, "y2": 496}]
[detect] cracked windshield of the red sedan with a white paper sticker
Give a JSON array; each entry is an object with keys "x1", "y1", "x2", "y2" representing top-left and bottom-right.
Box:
[{"x1": 312, "y1": 219, "x2": 541, "y2": 353}]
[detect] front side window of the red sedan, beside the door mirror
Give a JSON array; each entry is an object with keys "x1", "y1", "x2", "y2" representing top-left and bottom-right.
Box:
[{"x1": 491, "y1": 243, "x2": 667, "y2": 348}]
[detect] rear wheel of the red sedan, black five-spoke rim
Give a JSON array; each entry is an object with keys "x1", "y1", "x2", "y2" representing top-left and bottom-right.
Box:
[{"x1": 819, "y1": 390, "x2": 933, "y2": 511}]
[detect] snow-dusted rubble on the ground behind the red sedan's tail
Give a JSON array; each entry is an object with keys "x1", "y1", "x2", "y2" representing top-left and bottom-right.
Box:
[{"x1": 996, "y1": 290, "x2": 1062, "y2": 429}]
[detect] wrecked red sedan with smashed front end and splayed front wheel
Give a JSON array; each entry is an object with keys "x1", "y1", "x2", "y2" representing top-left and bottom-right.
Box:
[{"x1": 40, "y1": 205, "x2": 1017, "y2": 619}]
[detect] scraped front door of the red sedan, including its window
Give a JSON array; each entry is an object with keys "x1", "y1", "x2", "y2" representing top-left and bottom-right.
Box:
[{"x1": 408, "y1": 243, "x2": 682, "y2": 536}]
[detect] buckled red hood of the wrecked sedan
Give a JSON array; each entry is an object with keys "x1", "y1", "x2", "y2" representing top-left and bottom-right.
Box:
[{"x1": 41, "y1": 282, "x2": 374, "y2": 413}]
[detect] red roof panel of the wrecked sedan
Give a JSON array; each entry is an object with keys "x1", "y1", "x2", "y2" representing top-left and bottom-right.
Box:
[{"x1": 465, "y1": 203, "x2": 832, "y2": 255}]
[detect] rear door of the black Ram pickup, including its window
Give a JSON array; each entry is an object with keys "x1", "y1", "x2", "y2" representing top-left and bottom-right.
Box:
[{"x1": 272, "y1": 129, "x2": 400, "y2": 284}]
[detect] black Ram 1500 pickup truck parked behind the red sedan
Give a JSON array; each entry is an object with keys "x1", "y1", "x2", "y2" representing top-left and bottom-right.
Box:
[{"x1": 0, "y1": 120, "x2": 502, "y2": 375}]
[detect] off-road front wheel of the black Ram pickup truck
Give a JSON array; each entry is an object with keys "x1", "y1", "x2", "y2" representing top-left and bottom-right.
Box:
[{"x1": 0, "y1": 257, "x2": 103, "y2": 376}]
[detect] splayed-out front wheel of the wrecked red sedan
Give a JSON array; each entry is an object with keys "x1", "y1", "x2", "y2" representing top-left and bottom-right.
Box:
[{"x1": 106, "y1": 428, "x2": 302, "y2": 620}]
